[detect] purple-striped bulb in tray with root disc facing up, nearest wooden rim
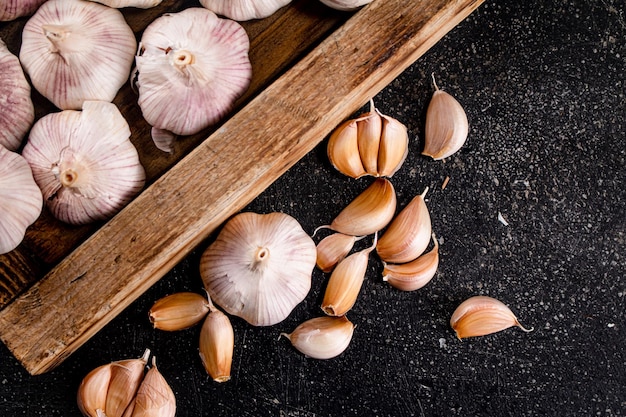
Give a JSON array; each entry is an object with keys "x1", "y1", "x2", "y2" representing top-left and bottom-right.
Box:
[{"x1": 22, "y1": 101, "x2": 145, "y2": 224}]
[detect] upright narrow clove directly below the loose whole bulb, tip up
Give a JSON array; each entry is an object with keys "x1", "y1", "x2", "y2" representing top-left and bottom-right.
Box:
[{"x1": 200, "y1": 304, "x2": 235, "y2": 382}]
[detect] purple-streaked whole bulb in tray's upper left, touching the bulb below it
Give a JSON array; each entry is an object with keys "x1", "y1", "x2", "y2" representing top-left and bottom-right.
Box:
[{"x1": 20, "y1": 0, "x2": 137, "y2": 110}]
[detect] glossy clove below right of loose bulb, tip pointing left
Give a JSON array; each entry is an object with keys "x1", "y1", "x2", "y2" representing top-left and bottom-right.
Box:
[{"x1": 281, "y1": 316, "x2": 354, "y2": 359}]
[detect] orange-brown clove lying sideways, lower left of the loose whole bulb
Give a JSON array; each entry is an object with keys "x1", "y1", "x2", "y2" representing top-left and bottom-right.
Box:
[{"x1": 149, "y1": 292, "x2": 209, "y2": 331}]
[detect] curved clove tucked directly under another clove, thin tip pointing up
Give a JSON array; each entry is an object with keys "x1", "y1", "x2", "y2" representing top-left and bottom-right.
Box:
[{"x1": 383, "y1": 233, "x2": 439, "y2": 291}]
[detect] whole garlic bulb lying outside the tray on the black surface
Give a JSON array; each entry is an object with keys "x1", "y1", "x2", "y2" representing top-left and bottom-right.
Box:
[{"x1": 200, "y1": 213, "x2": 317, "y2": 326}]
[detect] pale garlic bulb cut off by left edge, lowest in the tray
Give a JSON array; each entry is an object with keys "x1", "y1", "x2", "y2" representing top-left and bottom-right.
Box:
[{"x1": 0, "y1": 146, "x2": 43, "y2": 254}]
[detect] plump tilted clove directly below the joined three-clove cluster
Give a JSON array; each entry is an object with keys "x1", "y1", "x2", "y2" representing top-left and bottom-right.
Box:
[{"x1": 329, "y1": 178, "x2": 396, "y2": 236}]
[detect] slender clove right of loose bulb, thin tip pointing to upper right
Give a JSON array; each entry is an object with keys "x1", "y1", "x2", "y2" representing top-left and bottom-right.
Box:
[{"x1": 322, "y1": 235, "x2": 376, "y2": 316}]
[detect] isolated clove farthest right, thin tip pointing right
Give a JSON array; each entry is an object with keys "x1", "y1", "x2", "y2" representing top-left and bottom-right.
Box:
[{"x1": 450, "y1": 295, "x2": 532, "y2": 339}]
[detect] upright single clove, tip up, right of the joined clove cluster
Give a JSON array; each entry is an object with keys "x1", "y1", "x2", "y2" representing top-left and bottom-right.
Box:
[{"x1": 422, "y1": 75, "x2": 469, "y2": 160}]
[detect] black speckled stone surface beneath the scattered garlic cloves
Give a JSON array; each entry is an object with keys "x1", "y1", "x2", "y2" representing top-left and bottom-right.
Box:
[{"x1": 0, "y1": 0, "x2": 626, "y2": 417}]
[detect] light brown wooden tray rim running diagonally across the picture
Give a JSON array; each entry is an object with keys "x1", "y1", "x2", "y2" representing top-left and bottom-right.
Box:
[{"x1": 0, "y1": 0, "x2": 482, "y2": 374}]
